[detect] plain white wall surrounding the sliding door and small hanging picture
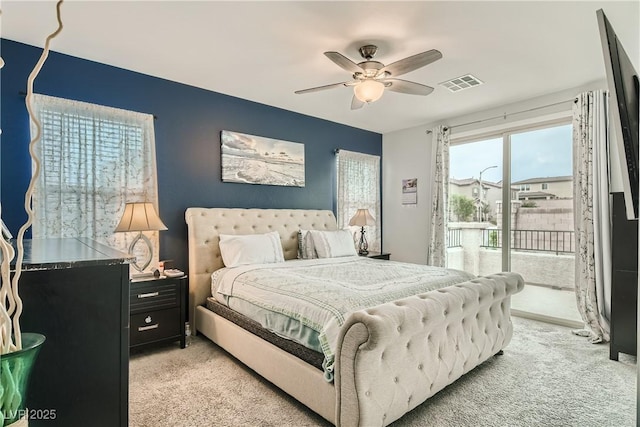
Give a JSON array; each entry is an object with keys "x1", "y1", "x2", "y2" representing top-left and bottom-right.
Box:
[{"x1": 382, "y1": 80, "x2": 608, "y2": 263}]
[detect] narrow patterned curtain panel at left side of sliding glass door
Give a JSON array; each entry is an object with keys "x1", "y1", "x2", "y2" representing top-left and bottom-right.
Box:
[{"x1": 427, "y1": 126, "x2": 450, "y2": 267}]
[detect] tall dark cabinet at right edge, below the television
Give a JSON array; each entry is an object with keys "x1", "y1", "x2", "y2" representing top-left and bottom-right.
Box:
[{"x1": 609, "y1": 193, "x2": 638, "y2": 360}]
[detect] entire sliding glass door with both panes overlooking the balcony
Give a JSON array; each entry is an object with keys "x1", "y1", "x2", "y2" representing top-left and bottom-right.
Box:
[{"x1": 448, "y1": 123, "x2": 580, "y2": 326}]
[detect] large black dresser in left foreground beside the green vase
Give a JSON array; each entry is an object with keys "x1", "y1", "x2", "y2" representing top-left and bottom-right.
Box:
[{"x1": 12, "y1": 238, "x2": 129, "y2": 427}]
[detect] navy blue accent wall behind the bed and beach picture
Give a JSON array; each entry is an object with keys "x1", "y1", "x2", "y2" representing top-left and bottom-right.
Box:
[{"x1": 0, "y1": 39, "x2": 382, "y2": 269}]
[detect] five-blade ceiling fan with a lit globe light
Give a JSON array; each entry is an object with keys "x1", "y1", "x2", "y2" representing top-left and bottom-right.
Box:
[{"x1": 295, "y1": 45, "x2": 442, "y2": 110}]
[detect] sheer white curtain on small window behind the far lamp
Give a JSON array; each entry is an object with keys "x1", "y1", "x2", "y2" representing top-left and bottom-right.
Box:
[{"x1": 336, "y1": 150, "x2": 381, "y2": 252}]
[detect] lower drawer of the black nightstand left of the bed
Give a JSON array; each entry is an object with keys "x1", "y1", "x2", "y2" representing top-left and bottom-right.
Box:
[{"x1": 129, "y1": 308, "x2": 181, "y2": 346}]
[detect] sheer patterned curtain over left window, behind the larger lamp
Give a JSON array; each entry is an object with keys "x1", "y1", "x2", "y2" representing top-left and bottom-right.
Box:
[{"x1": 31, "y1": 95, "x2": 158, "y2": 264}]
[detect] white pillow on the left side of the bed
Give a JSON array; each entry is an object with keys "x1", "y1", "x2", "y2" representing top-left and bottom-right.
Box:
[{"x1": 220, "y1": 231, "x2": 284, "y2": 267}]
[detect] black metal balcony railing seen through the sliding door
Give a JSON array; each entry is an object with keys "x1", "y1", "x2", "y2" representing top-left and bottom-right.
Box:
[{"x1": 480, "y1": 229, "x2": 575, "y2": 254}]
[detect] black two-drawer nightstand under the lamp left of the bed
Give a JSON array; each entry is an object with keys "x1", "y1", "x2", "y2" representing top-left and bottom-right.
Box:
[{"x1": 129, "y1": 276, "x2": 188, "y2": 348}]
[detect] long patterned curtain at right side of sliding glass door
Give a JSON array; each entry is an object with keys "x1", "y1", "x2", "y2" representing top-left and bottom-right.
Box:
[{"x1": 573, "y1": 90, "x2": 611, "y2": 342}]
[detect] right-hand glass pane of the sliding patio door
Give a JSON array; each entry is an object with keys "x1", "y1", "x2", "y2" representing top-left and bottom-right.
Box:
[{"x1": 509, "y1": 124, "x2": 582, "y2": 326}]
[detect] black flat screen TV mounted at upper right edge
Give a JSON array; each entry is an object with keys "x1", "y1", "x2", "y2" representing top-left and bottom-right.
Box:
[{"x1": 596, "y1": 9, "x2": 640, "y2": 219}]
